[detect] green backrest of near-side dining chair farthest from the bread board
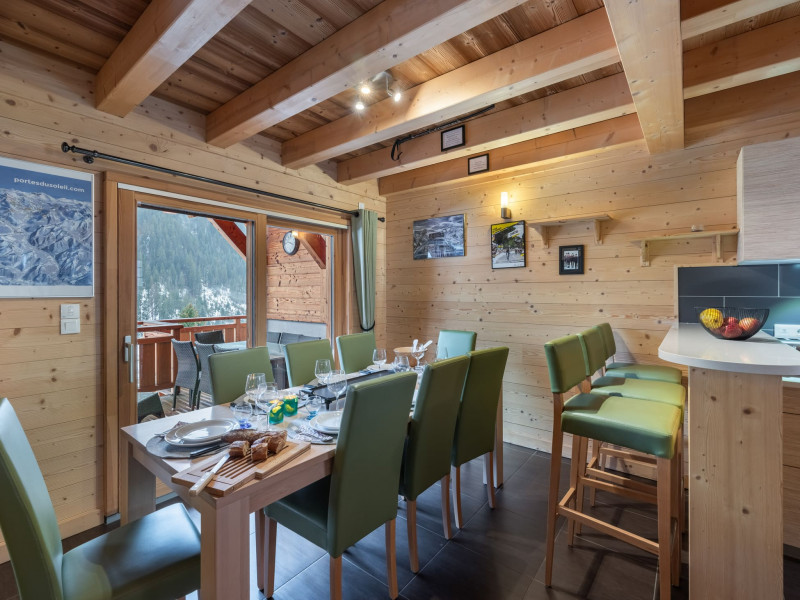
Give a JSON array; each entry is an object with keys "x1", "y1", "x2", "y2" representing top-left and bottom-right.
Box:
[{"x1": 450, "y1": 347, "x2": 508, "y2": 466}]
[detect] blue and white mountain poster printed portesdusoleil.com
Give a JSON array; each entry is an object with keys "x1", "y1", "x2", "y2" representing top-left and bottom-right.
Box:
[{"x1": 0, "y1": 157, "x2": 94, "y2": 298}]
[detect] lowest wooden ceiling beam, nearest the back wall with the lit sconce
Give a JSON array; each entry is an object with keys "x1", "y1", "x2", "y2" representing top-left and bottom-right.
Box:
[{"x1": 378, "y1": 115, "x2": 642, "y2": 196}]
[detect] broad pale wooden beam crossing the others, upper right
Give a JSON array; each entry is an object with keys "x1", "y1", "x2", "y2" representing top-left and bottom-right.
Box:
[{"x1": 605, "y1": 0, "x2": 683, "y2": 154}]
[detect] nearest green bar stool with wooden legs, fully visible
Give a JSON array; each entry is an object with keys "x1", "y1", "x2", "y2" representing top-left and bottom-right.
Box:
[{"x1": 544, "y1": 335, "x2": 681, "y2": 600}]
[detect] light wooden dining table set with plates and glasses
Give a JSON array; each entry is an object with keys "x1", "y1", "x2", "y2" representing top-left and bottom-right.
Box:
[{"x1": 119, "y1": 366, "x2": 502, "y2": 600}]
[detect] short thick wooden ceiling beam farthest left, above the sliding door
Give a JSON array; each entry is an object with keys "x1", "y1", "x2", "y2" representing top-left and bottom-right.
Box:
[{"x1": 95, "y1": 0, "x2": 250, "y2": 117}]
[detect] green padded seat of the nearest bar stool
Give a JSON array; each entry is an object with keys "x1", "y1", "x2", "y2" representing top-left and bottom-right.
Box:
[{"x1": 561, "y1": 392, "x2": 681, "y2": 458}]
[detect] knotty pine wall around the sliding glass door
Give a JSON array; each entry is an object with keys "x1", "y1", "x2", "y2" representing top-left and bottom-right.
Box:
[{"x1": 0, "y1": 42, "x2": 385, "y2": 561}]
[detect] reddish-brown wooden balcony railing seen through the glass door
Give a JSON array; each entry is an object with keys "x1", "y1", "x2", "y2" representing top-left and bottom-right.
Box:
[{"x1": 137, "y1": 315, "x2": 247, "y2": 392}]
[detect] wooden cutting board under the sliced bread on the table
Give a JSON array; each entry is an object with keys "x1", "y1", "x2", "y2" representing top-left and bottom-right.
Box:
[{"x1": 172, "y1": 441, "x2": 311, "y2": 496}]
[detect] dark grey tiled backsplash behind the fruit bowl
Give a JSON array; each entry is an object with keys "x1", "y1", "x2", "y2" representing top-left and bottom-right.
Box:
[{"x1": 678, "y1": 263, "x2": 800, "y2": 334}]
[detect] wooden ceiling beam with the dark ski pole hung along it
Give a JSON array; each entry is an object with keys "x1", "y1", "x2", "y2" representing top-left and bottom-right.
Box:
[{"x1": 338, "y1": 73, "x2": 636, "y2": 184}]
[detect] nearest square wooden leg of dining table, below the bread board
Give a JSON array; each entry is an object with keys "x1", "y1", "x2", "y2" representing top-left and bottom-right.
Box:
[{"x1": 200, "y1": 500, "x2": 250, "y2": 600}]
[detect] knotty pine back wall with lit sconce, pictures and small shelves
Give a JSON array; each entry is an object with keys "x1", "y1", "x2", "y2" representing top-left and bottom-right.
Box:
[{"x1": 386, "y1": 69, "x2": 800, "y2": 452}]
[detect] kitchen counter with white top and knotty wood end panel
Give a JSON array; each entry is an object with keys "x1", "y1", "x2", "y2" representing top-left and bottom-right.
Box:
[{"x1": 658, "y1": 324, "x2": 800, "y2": 600}]
